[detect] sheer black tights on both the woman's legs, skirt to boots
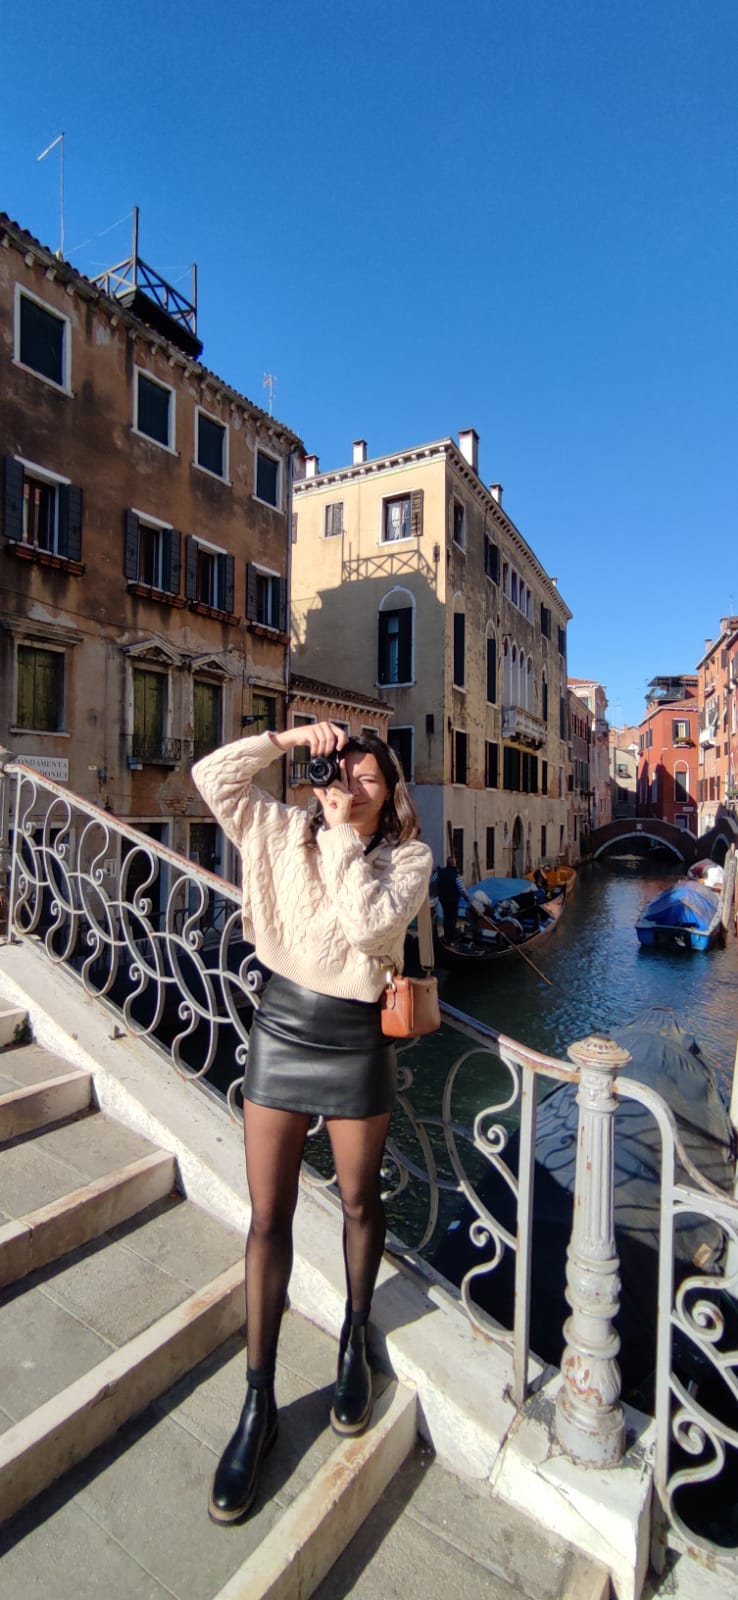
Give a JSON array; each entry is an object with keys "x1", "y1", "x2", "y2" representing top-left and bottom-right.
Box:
[{"x1": 243, "y1": 1101, "x2": 389, "y2": 1374}]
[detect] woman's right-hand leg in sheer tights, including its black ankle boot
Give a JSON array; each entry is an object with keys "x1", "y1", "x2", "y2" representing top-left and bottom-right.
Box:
[{"x1": 328, "y1": 1112, "x2": 389, "y2": 1434}]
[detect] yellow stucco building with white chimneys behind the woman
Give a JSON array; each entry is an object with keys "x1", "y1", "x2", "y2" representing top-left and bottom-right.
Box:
[{"x1": 291, "y1": 429, "x2": 572, "y2": 880}]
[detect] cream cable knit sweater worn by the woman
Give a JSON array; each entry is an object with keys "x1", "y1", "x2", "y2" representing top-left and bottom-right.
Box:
[{"x1": 192, "y1": 733, "x2": 432, "y2": 1000}]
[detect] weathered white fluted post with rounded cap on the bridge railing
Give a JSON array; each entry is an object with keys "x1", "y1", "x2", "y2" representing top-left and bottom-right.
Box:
[{"x1": 556, "y1": 1034, "x2": 631, "y2": 1467}]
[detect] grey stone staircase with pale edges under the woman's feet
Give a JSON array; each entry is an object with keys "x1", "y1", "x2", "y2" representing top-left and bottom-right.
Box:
[{"x1": 0, "y1": 1011, "x2": 608, "y2": 1600}]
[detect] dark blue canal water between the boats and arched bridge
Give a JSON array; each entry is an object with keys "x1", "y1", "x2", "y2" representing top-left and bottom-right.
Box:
[{"x1": 442, "y1": 859, "x2": 738, "y2": 1090}]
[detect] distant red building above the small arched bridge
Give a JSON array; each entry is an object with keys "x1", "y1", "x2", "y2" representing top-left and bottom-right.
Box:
[{"x1": 637, "y1": 674, "x2": 700, "y2": 837}]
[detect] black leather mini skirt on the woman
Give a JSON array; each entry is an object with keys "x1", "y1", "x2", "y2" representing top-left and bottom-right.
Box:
[{"x1": 243, "y1": 973, "x2": 397, "y2": 1117}]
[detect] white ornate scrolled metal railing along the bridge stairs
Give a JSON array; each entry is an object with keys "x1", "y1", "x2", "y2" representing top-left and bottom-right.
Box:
[{"x1": 0, "y1": 763, "x2": 738, "y2": 1560}]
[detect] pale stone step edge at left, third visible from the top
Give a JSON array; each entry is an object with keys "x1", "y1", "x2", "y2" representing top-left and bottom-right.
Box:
[{"x1": 0, "y1": 1150, "x2": 176, "y2": 1288}]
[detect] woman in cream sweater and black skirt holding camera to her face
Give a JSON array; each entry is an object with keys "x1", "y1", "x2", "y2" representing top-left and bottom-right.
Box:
[{"x1": 192, "y1": 722, "x2": 432, "y2": 1522}]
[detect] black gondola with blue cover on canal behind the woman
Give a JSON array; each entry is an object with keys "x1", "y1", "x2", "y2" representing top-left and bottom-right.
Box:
[{"x1": 434, "y1": 878, "x2": 565, "y2": 971}]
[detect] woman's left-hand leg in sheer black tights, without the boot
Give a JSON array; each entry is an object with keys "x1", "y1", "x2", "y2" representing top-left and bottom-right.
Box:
[{"x1": 243, "y1": 1101, "x2": 312, "y2": 1373}]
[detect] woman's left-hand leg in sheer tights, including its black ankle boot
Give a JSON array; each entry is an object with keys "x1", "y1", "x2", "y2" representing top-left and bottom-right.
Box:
[{"x1": 208, "y1": 1101, "x2": 311, "y2": 1523}]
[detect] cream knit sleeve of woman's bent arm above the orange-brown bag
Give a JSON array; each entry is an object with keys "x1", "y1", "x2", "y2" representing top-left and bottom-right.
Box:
[{"x1": 317, "y1": 822, "x2": 432, "y2": 957}]
